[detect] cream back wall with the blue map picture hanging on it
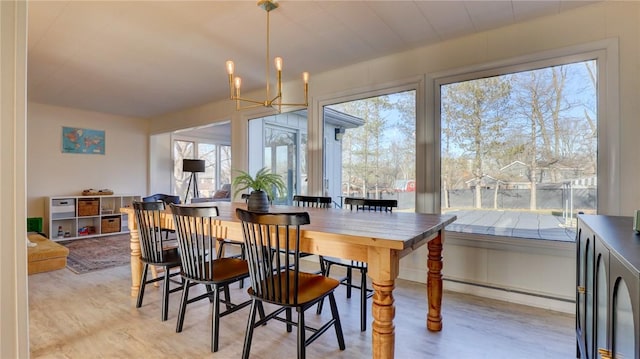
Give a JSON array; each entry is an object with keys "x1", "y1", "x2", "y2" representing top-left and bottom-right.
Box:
[{"x1": 27, "y1": 102, "x2": 149, "y2": 235}]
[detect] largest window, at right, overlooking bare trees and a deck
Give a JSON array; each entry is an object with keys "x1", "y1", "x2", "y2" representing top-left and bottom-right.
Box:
[{"x1": 439, "y1": 59, "x2": 598, "y2": 241}]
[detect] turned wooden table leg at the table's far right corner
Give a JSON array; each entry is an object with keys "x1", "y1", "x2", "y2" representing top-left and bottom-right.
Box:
[{"x1": 427, "y1": 231, "x2": 444, "y2": 332}]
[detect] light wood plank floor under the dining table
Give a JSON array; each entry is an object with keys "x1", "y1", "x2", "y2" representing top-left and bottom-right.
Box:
[{"x1": 29, "y1": 266, "x2": 575, "y2": 359}]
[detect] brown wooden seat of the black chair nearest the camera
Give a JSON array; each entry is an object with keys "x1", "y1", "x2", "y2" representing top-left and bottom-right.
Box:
[{"x1": 248, "y1": 271, "x2": 340, "y2": 306}]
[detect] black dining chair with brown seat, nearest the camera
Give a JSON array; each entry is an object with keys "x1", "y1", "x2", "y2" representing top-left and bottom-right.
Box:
[{"x1": 236, "y1": 208, "x2": 345, "y2": 359}]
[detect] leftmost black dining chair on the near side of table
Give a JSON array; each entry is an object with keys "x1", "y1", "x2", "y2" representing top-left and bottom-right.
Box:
[{"x1": 133, "y1": 201, "x2": 184, "y2": 321}]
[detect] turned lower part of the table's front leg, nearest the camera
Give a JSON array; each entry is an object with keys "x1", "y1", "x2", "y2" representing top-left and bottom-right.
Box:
[{"x1": 371, "y1": 280, "x2": 396, "y2": 359}]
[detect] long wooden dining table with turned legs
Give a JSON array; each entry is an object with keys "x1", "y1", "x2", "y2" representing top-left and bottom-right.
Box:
[{"x1": 120, "y1": 202, "x2": 456, "y2": 358}]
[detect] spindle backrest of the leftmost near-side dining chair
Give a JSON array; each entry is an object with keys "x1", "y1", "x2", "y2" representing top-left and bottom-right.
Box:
[{"x1": 133, "y1": 201, "x2": 170, "y2": 263}]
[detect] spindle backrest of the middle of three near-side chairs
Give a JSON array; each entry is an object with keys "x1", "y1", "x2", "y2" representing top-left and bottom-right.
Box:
[{"x1": 169, "y1": 204, "x2": 221, "y2": 281}]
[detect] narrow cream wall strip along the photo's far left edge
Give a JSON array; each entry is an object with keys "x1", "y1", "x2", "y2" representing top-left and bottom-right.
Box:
[{"x1": 0, "y1": 1, "x2": 29, "y2": 358}]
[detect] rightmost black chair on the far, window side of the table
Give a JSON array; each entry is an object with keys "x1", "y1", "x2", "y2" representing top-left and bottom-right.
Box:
[{"x1": 317, "y1": 197, "x2": 398, "y2": 332}]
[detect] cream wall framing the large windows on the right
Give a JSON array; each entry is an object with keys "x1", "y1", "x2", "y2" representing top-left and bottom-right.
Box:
[{"x1": 146, "y1": 1, "x2": 640, "y2": 311}]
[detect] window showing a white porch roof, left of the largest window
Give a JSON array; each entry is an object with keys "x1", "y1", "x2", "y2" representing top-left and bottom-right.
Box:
[{"x1": 323, "y1": 90, "x2": 416, "y2": 211}]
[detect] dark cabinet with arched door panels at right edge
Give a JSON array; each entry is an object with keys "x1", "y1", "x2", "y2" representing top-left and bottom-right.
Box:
[{"x1": 576, "y1": 215, "x2": 640, "y2": 359}]
